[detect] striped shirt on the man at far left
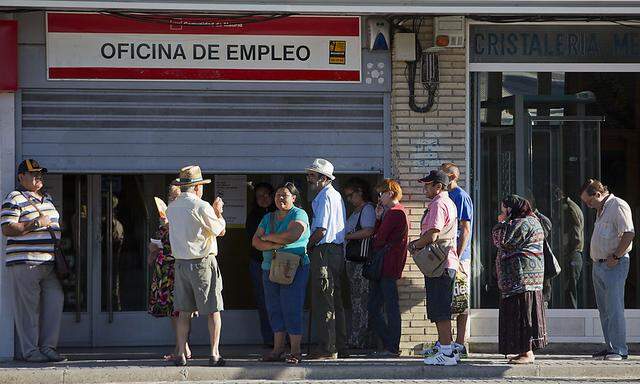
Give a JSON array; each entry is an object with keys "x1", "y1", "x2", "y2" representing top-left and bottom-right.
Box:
[{"x1": 0, "y1": 190, "x2": 60, "y2": 266}]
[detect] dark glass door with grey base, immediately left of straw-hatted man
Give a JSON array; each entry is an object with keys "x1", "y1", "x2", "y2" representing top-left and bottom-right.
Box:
[{"x1": 92, "y1": 175, "x2": 173, "y2": 346}]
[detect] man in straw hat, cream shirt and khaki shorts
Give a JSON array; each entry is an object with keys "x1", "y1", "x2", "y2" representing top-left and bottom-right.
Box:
[{"x1": 167, "y1": 165, "x2": 226, "y2": 366}]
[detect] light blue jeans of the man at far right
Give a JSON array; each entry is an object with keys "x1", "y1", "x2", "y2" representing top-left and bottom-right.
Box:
[{"x1": 593, "y1": 255, "x2": 629, "y2": 355}]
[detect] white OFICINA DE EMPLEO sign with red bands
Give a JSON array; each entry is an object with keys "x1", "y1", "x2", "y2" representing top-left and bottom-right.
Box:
[{"x1": 47, "y1": 12, "x2": 361, "y2": 83}]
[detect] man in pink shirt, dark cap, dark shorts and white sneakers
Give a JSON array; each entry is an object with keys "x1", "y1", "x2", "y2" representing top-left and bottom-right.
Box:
[{"x1": 409, "y1": 171, "x2": 459, "y2": 365}]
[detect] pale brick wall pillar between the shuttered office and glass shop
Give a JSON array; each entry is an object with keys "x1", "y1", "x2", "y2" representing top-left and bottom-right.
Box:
[{"x1": 391, "y1": 17, "x2": 467, "y2": 355}]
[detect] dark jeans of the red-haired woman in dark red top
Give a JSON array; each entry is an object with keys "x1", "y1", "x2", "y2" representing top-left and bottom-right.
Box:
[{"x1": 368, "y1": 277, "x2": 401, "y2": 353}]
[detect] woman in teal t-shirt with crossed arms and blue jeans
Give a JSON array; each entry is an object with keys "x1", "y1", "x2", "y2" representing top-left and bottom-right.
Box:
[{"x1": 252, "y1": 183, "x2": 310, "y2": 364}]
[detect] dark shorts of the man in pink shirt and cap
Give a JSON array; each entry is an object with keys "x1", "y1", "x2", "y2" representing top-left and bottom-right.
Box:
[{"x1": 424, "y1": 268, "x2": 456, "y2": 323}]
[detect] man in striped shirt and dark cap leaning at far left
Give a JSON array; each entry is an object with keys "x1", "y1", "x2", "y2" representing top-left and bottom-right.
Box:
[{"x1": 0, "y1": 159, "x2": 64, "y2": 363}]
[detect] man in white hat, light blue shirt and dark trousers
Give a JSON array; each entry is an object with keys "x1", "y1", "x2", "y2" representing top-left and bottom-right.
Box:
[{"x1": 306, "y1": 159, "x2": 347, "y2": 360}]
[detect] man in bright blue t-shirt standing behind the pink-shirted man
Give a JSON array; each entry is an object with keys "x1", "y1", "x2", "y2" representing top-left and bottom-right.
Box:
[{"x1": 440, "y1": 163, "x2": 473, "y2": 357}]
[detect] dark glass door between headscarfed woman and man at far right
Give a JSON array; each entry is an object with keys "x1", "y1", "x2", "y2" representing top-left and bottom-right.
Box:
[{"x1": 526, "y1": 116, "x2": 603, "y2": 309}]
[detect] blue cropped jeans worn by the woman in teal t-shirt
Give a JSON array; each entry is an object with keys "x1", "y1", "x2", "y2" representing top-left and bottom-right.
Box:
[{"x1": 262, "y1": 264, "x2": 309, "y2": 335}]
